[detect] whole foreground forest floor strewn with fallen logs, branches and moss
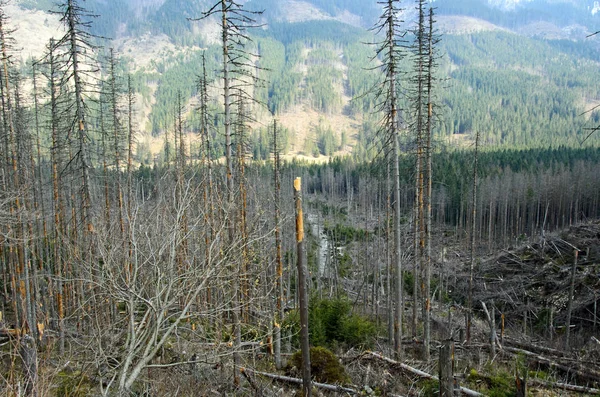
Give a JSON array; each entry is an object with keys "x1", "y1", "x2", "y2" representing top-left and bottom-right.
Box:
[{"x1": 4, "y1": 221, "x2": 600, "y2": 397}]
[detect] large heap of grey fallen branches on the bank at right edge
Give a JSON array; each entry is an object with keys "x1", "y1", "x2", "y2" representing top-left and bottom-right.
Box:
[{"x1": 474, "y1": 222, "x2": 600, "y2": 329}]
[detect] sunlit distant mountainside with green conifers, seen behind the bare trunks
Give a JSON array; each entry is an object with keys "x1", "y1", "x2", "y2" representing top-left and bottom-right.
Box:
[{"x1": 10, "y1": 0, "x2": 600, "y2": 159}]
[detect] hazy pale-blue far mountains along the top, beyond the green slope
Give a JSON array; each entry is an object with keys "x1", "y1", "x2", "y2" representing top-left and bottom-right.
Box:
[{"x1": 17, "y1": 0, "x2": 600, "y2": 38}]
